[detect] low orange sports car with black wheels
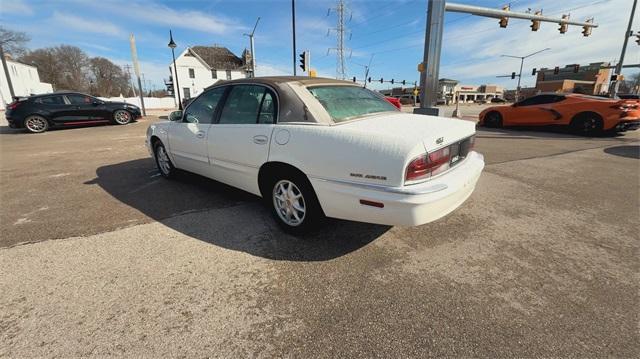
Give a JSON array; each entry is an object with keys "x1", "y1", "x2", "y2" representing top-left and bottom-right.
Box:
[{"x1": 478, "y1": 93, "x2": 640, "y2": 134}]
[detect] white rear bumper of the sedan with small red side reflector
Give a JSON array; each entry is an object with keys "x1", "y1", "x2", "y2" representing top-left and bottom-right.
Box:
[{"x1": 310, "y1": 152, "x2": 484, "y2": 226}]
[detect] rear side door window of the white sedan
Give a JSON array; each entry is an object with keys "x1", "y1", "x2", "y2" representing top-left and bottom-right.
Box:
[{"x1": 219, "y1": 85, "x2": 277, "y2": 124}]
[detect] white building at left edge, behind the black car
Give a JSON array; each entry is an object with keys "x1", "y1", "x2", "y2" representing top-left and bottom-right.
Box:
[{"x1": 0, "y1": 58, "x2": 53, "y2": 108}]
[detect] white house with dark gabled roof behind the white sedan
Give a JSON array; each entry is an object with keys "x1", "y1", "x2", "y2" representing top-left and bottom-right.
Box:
[{"x1": 169, "y1": 46, "x2": 251, "y2": 105}]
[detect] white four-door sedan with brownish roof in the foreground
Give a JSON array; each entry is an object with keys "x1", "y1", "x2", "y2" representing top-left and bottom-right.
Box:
[{"x1": 146, "y1": 77, "x2": 484, "y2": 232}]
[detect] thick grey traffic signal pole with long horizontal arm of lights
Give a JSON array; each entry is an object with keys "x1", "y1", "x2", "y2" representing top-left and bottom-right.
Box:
[{"x1": 414, "y1": 0, "x2": 600, "y2": 115}]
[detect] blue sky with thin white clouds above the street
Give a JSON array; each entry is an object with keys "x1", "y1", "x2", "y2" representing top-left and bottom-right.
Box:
[{"x1": 0, "y1": 0, "x2": 640, "y2": 89}]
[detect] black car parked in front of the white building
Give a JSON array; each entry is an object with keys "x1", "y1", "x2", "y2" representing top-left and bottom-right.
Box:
[{"x1": 5, "y1": 92, "x2": 141, "y2": 133}]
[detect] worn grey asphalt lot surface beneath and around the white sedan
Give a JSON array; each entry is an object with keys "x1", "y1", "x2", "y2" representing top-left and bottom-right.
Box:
[{"x1": 0, "y1": 118, "x2": 640, "y2": 357}]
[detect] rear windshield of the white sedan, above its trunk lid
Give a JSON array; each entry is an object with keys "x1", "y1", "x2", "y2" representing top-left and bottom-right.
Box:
[{"x1": 309, "y1": 86, "x2": 397, "y2": 122}]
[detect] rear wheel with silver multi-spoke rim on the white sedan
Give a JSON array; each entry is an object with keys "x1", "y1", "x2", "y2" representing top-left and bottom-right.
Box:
[{"x1": 264, "y1": 171, "x2": 325, "y2": 234}]
